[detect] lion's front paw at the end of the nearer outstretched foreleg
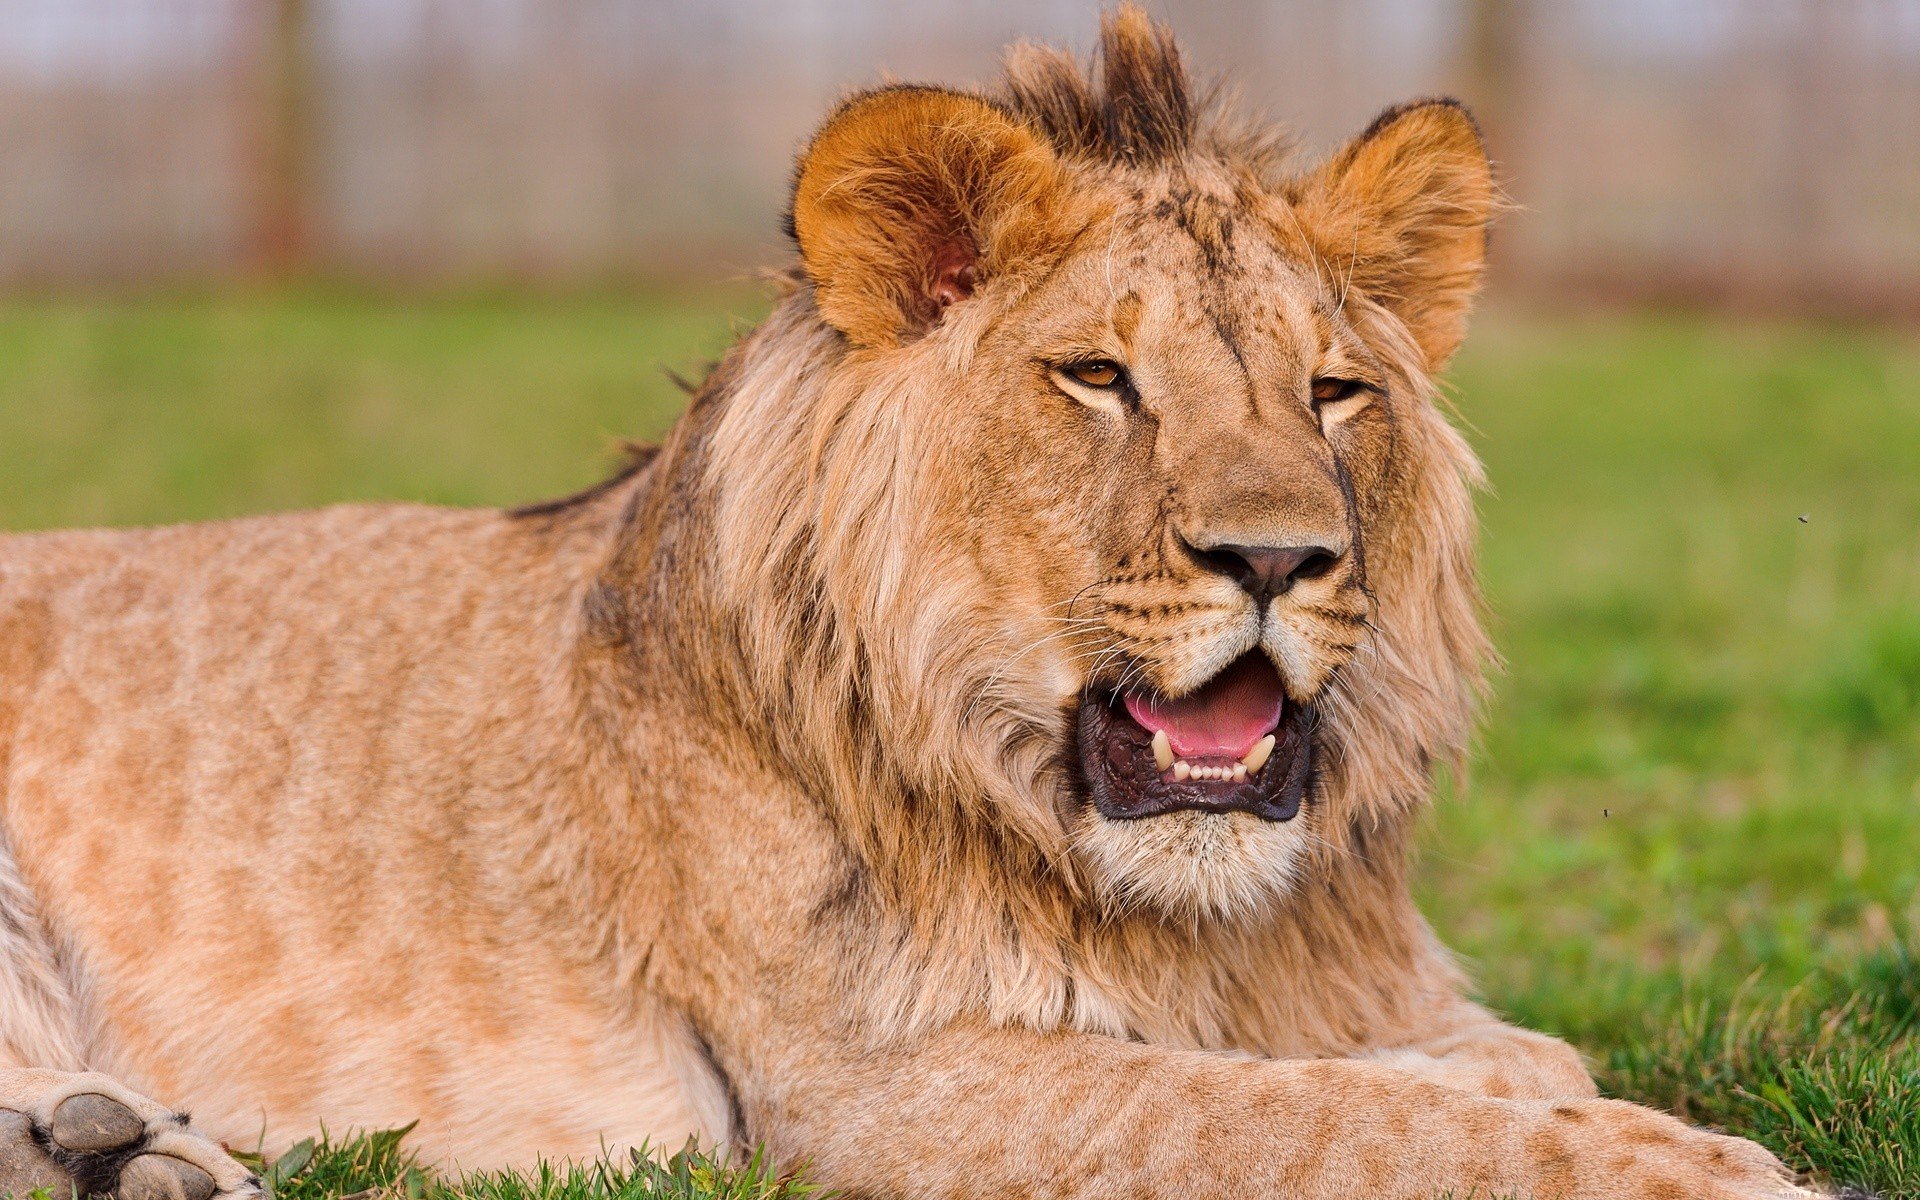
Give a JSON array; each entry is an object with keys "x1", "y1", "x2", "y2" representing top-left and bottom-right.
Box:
[{"x1": 1524, "y1": 1100, "x2": 1818, "y2": 1200}]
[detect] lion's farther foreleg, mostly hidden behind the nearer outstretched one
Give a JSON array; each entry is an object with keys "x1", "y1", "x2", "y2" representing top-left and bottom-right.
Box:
[{"x1": 1371, "y1": 1006, "x2": 1597, "y2": 1100}]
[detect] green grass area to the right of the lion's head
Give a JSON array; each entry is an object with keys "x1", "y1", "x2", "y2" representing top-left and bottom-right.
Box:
[{"x1": 1421, "y1": 319, "x2": 1920, "y2": 1196}]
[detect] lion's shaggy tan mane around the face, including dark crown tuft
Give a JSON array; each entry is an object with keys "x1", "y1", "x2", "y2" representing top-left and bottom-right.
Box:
[{"x1": 576, "y1": 10, "x2": 1488, "y2": 1054}]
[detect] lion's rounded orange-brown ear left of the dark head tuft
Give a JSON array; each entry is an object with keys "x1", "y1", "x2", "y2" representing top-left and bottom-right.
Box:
[{"x1": 791, "y1": 86, "x2": 1066, "y2": 346}]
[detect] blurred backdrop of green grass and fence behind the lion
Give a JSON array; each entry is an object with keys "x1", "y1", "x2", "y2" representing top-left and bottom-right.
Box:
[{"x1": 0, "y1": 0, "x2": 1920, "y2": 1198}]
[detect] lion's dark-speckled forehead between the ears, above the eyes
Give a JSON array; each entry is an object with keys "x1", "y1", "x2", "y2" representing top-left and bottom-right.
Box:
[{"x1": 1044, "y1": 175, "x2": 1344, "y2": 362}]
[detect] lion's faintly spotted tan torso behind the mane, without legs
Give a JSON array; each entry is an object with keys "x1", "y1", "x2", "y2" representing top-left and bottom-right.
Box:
[{"x1": 0, "y1": 507, "x2": 724, "y2": 1164}]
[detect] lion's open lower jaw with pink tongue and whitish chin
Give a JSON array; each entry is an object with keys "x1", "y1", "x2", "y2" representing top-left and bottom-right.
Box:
[{"x1": 1073, "y1": 651, "x2": 1315, "y2": 920}]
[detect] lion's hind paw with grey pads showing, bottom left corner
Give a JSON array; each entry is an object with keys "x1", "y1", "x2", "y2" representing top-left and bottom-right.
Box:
[{"x1": 0, "y1": 1064, "x2": 259, "y2": 1200}]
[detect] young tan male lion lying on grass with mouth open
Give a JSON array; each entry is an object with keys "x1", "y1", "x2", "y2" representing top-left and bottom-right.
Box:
[{"x1": 0, "y1": 8, "x2": 1801, "y2": 1200}]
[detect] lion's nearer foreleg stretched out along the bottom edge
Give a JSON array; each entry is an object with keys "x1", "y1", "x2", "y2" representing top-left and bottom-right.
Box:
[{"x1": 756, "y1": 1029, "x2": 1807, "y2": 1200}]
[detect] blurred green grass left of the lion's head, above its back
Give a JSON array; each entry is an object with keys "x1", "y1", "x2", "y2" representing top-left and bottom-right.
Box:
[{"x1": 0, "y1": 286, "x2": 764, "y2": 528}]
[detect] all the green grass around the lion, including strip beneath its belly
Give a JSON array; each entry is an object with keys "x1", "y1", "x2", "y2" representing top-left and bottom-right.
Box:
[{"x1": 0, "y1": 290, "x2": 1920, "y2": 1200}]
